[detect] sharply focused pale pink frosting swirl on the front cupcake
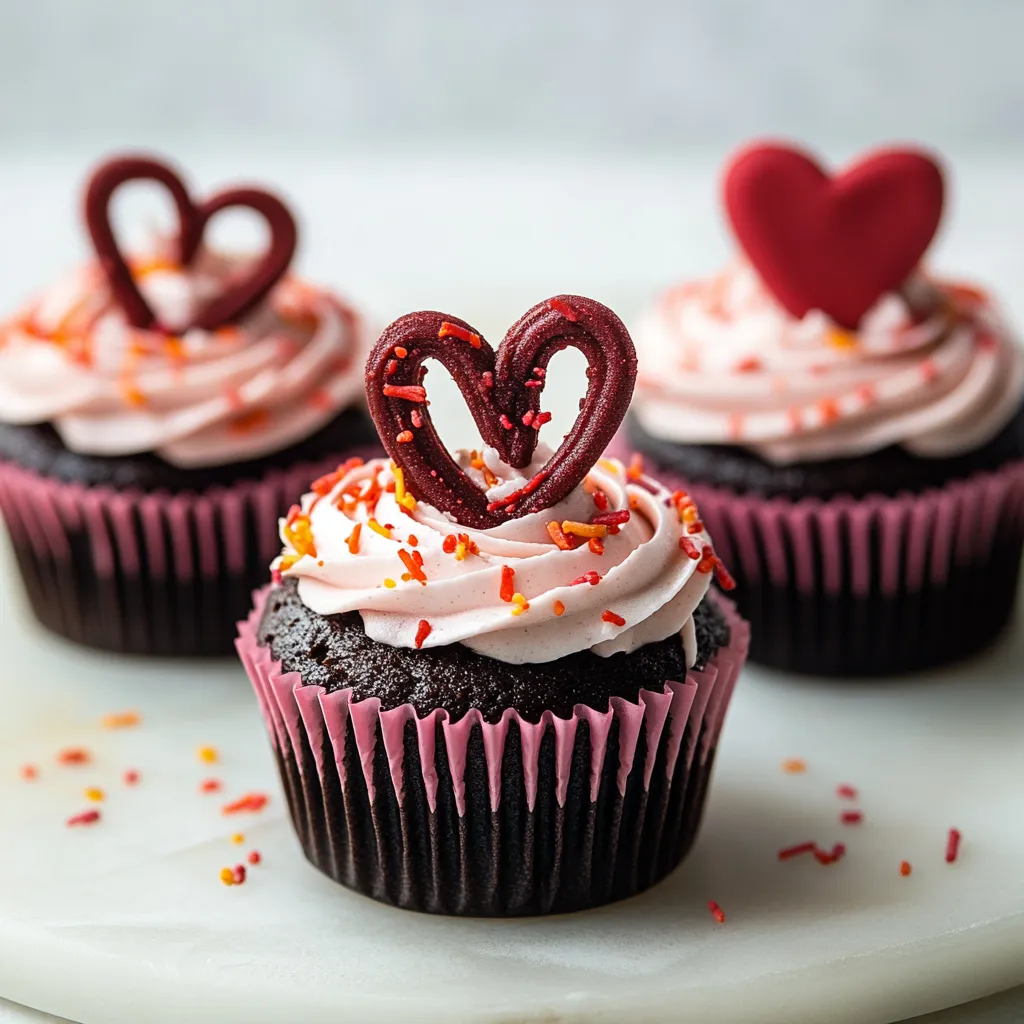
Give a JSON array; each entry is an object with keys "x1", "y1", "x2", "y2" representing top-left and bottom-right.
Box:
[{"x1": 274, "y1": 445, "x2": 717, "y2": 665}]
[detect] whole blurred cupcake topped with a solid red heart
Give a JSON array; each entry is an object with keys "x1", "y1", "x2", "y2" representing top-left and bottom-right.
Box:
[{"x1": 612, "y1": 145, "x2": 1024, "y2": 676}]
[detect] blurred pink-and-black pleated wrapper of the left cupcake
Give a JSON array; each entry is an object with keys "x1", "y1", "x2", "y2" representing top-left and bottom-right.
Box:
[{"x1": 0, "y1": 458, "x2": 378, "y2": 656}]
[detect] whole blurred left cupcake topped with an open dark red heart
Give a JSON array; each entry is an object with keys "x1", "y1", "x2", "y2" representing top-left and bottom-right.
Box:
[{"x1": 0, "y1": 158, "x2": 380, "y2": 655}]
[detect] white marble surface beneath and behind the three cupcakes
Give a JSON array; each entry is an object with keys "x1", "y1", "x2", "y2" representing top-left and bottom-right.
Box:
[{"x1": 0, "y1": 158, "x2": 1024, "y2": 1024}]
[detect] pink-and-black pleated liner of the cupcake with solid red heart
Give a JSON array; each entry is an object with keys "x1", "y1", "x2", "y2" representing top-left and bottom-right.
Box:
[{"x1": 609, "y1": 437, "x2": 1024, "y2": 677}]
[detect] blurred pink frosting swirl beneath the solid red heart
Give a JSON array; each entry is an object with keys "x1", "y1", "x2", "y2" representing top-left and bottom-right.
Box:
[{"x1": 634, "y1": 264, "x2": 1024, "y2": 465}]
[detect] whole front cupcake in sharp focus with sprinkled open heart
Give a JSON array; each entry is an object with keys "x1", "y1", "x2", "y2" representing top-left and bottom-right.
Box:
[{"x1": 238, "y1": 296, "x2": 748, "y2": 915}]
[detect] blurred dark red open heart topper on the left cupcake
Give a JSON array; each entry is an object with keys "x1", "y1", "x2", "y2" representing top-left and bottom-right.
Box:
[{"x1": 85, "y1": 157, "x2": 298, "y2": 331}]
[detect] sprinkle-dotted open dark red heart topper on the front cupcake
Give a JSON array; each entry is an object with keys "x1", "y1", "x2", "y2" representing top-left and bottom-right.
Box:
[{"x1": 367, "y1": 295, "x2": 637, "y2": 529}]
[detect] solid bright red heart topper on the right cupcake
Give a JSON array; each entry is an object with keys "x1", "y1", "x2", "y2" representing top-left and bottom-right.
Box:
[{"x1": 724, "y1": 145, "x2": 943, "y2": 330}]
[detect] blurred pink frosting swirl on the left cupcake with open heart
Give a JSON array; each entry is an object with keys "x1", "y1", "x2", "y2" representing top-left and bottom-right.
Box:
[{"x1": 0, "y1": 246, "x2": 369, "y2": 468}]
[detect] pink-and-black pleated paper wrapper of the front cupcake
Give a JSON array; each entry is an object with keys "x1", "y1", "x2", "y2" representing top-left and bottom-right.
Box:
[{"x1": 237, "y1": 588, "x2": 749, "y2": 916}]
